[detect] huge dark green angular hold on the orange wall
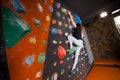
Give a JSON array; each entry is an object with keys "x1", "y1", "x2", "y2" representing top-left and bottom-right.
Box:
[{"x1": 1, "y1": 7, "x2": 31, "y2": 48}]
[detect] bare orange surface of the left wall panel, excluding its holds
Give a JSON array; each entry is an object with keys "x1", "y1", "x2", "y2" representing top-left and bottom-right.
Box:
[{"x1": 1, "y1": 0, "x2": 54, "y2": 80}]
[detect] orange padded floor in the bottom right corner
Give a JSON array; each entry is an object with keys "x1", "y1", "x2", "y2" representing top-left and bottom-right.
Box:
[{"x1": 85, "y1": 66, "x2": 120, "y2": 80}]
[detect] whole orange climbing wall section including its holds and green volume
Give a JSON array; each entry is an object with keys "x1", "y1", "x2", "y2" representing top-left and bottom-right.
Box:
[{"x1": 0, "y1": 0, "x2": 54, "y2": 80}]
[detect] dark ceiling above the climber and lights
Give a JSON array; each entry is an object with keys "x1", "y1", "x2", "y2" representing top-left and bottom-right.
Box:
[{"x1": 61, "y1": 0, "x2": 120, "y2": 24}]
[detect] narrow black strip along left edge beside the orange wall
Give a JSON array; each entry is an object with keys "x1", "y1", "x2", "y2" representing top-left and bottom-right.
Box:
[{"x1": 0, "y1": 18, "x2": 9, "y2": 80}]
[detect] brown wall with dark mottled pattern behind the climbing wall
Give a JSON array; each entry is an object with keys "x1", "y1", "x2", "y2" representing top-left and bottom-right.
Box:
[{"x1": 86, "y1": 16, "x2": 120, "y2": 60}]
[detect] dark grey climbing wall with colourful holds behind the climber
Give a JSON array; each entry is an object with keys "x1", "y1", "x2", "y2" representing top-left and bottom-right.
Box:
[{"x1": 43, "y1": 1, "x2": 91, "y2": 80}]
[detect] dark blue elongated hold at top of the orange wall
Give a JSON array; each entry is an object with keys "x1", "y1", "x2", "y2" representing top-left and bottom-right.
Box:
[{"x1": 11, "y1": 0, "x2": 26, "y2": 14}]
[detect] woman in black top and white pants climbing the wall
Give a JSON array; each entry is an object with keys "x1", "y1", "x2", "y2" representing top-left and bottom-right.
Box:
[{"x1": 68, "y1": 11, "x2": 83, "y2": 70}]
